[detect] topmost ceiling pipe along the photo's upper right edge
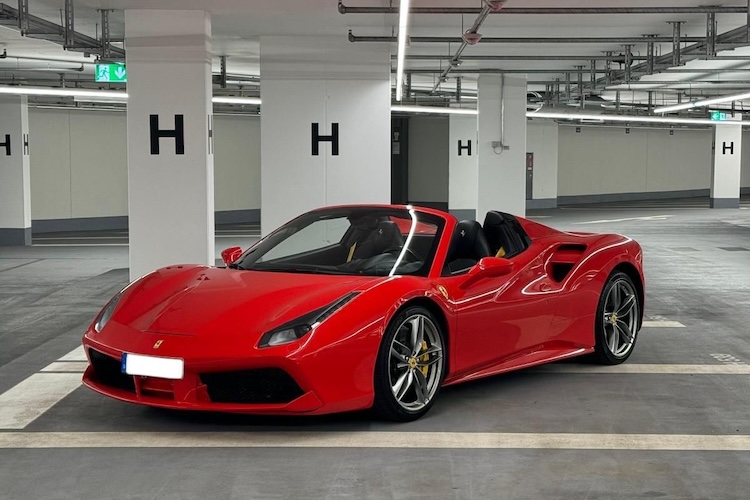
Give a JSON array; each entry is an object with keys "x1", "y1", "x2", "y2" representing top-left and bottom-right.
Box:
[{"x1": 338, "y1": 2, "x2": 747, "y2": 15}]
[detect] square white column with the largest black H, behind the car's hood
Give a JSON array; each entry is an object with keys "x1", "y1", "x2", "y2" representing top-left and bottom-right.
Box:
[{"x1": 125, "y1": 10, "x2": 215, "y2": 278}]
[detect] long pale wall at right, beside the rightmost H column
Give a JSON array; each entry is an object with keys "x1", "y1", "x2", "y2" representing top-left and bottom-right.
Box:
[{"x1": 558, "y1": 126, "x2": 713, "y2": 196}]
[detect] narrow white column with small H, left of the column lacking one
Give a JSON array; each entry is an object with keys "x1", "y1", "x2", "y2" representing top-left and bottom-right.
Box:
[{"x1": 448, "y1": 115, "x2": 481, "y2": 222}]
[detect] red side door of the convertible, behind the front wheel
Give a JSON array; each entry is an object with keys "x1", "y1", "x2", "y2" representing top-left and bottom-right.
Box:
[{"x1": 441, "y1": 249, "x2": 552, "y2": 373}]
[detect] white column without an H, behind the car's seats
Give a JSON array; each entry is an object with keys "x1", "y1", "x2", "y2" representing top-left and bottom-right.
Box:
[{"x1": 477, "y1": 75, "x2": 526, "y2": 220}]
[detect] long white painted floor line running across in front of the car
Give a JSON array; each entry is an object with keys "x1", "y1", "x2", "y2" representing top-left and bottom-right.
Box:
[{"x1": 0, "y1": 431, "x2": 750, "y2": 451}]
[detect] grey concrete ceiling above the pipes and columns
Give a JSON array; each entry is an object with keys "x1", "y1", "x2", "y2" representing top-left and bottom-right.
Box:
[{"x1": 0, "y1": 0, "x2": 750, "y2": 111}]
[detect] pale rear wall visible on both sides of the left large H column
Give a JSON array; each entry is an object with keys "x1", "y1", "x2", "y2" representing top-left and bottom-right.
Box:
[{"x1": 29, "y1": 109, "x2": 260, "y2": 220}]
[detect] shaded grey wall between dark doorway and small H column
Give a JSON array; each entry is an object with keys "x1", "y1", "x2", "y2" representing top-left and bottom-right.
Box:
[{"x1": 409, "y1": 116, "x2": 449, "y2": 204}]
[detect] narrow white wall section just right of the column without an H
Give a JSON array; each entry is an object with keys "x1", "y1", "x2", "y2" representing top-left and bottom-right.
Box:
[{"x1": 526, "y1": 120, "x2": 558, "y2": 200}]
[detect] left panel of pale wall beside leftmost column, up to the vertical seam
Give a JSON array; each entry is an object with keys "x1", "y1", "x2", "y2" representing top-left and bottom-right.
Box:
[{"x1": 29, "y1": 108, "x2": 72, "y2": 220}]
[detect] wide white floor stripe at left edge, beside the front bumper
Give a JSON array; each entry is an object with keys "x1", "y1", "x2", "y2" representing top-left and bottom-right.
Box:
[{"x1": 0, "y1": 373, "x2": 81, "y2": 429}]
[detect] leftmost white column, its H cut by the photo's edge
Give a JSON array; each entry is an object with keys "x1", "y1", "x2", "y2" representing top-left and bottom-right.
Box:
[{"x1": 0, "y1": 96, "x2": 31, "y2": 246}]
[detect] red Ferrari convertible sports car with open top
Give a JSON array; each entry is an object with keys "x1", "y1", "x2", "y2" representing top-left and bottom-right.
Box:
[{"x1": 83, "y1": 205, "x2": 644, "y2": 421}]
